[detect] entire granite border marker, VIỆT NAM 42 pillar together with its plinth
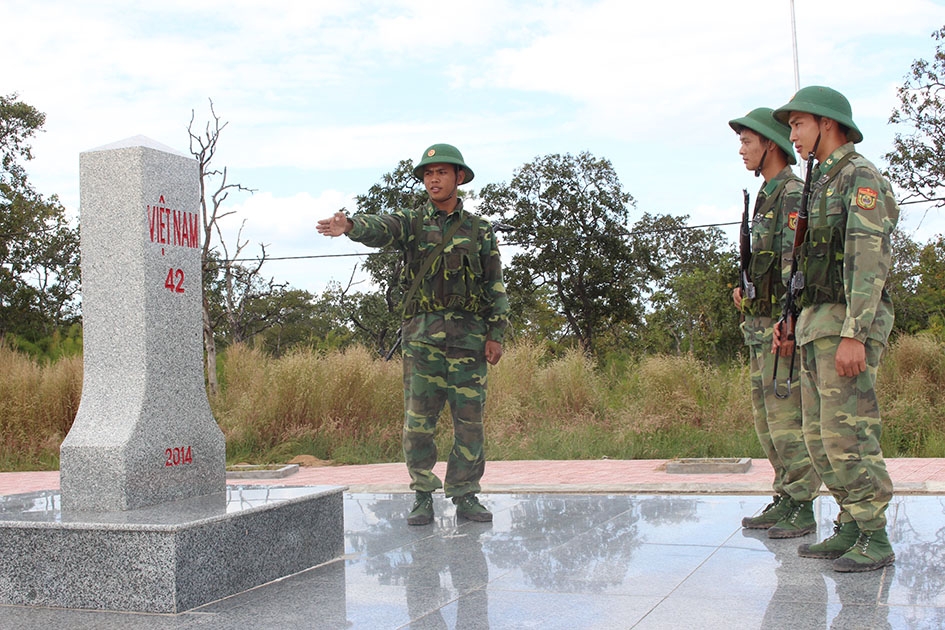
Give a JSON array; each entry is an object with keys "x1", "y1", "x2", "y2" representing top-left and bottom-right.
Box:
[{"x1": 0, "y1": 136, "x2": 344, "y2": 613}]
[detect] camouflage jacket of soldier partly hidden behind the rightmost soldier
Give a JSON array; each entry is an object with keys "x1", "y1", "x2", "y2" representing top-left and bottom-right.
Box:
[{"x1": 742, "y1": 166, "x2": 804, "y2": 346}]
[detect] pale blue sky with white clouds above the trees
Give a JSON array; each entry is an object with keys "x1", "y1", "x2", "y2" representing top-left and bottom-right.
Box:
[{"x1": 0, "y1": 0, "x2": 945, "y2": 293}]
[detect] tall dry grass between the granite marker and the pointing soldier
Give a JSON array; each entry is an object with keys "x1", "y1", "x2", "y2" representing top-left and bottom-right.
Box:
[{"x1": 210, "y1": 346, "x2": 403, "y2": 463}]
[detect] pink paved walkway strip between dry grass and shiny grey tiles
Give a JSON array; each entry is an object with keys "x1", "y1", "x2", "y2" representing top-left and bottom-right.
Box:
[{"x1": 0, "y1": 458, "x2": 945, "y2": 495}]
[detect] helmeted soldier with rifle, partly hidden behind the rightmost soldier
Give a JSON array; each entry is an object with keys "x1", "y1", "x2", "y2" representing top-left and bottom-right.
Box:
[{"x1": 728, "y1": 107, "x2": 820, "y2": 538}]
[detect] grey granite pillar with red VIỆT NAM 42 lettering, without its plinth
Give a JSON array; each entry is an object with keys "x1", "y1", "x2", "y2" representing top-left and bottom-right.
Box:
[{"x1": 60, "y1": 136, "x2": 226, "y2": 511}]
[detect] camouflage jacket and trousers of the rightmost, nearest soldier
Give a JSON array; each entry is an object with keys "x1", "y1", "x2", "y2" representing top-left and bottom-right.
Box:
[{"x1": 796, "y1": 142, "x2": 899, "y2": 532}]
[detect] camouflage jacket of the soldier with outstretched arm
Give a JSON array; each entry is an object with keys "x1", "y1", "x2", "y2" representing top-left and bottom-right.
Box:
[{"x1": 348, "y1": 200, "x2": 509, "y2": 349}]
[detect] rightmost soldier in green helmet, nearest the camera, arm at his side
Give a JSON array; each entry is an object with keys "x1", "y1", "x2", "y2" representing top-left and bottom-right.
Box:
[{"x1": 773, "y1": 86, "x2": 899, "y2": 572}]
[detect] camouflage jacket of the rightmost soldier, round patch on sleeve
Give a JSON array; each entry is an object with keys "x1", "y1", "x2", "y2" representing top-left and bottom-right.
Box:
[{"x1": 796, "y1": 143, "x2": 899, "y2": 344}]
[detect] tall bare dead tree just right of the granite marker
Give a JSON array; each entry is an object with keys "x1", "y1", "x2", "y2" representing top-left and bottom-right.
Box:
[{"x1": 187, "y1": 99, "x2": 256, "y2": 394}]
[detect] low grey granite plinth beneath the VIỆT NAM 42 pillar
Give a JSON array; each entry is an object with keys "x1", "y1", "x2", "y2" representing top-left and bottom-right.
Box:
[{"x1": 0, "y1": 486, "x2": 344, "y2": 613}]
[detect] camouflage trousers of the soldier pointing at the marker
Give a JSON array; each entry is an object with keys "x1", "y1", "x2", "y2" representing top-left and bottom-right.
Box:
[{"x1": 403, "y1": 341, "x2": 487, "y2": 497}]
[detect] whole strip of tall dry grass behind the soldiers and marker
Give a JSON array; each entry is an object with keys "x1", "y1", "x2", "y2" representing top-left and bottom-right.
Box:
[{"x1": 0, "y1": 335, "x2": 945, "y2": 471}]
